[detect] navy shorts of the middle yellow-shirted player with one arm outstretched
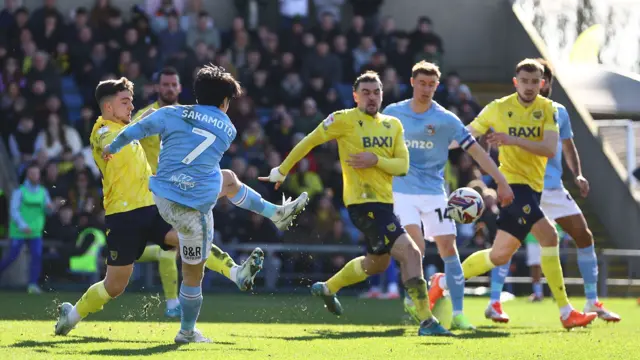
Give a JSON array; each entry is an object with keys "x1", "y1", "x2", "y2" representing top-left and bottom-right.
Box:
[{"x1": 347, "y1": 202, "x2": 405, "y2": 255}]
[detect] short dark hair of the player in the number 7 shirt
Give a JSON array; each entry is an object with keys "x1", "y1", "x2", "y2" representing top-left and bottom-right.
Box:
[{"x1": 193, "y1": 64, "x2": 242, "y2": 106}]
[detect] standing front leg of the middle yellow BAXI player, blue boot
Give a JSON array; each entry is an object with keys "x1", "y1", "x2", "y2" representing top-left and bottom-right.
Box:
[{"x1": 391, "y1": 233, "x2": 453, "y2": 336}]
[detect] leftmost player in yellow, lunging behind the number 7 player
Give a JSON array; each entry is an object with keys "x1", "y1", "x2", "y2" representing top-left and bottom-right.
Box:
[{"x1": 55, "y1": 78, "x2": 264, "y2": 335}]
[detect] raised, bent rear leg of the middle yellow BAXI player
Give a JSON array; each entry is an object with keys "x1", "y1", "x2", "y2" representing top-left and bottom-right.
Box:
[{"x1": 311, "y1": 254, "x2": 370, "y2": 316}]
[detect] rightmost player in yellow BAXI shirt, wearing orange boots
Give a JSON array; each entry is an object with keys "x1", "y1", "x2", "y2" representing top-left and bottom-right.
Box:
[{"x1": 429, "y1": 59, "x2": 597, "y2": 329}]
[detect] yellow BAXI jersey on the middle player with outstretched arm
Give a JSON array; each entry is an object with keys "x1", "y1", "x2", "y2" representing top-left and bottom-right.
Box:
[{"x1": 280, "y1": 108, "x2": 409, "y2": 206}]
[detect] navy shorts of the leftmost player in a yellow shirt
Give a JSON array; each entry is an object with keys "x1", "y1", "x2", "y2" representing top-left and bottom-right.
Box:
[{"x1": 105, "y1": 205, "x2": 172, "y2": 266}]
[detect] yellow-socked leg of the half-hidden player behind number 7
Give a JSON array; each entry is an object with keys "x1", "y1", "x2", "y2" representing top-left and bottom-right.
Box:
[{"x1": 136, "y1": 245, "x2": 181, "y2": 318}]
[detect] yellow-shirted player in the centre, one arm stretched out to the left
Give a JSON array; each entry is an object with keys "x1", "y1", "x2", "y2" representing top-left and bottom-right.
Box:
[{"x1": 260, "y1": 72, "x2": 451, "y2": 335}]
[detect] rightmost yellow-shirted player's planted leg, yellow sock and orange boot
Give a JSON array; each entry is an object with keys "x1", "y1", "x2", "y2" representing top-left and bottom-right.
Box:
[{"x1": 531, "y1": 218, "x2": 598, "y2": 329}]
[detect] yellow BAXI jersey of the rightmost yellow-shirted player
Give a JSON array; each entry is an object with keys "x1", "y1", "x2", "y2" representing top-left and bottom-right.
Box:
[{"x1": 470, "y1": 93, "x2": 558, "y2": 192}]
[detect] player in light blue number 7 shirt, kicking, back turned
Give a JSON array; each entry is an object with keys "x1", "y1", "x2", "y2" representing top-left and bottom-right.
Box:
[{"x1": 103, "y1": 66, "x2": 307, "y2": 343}]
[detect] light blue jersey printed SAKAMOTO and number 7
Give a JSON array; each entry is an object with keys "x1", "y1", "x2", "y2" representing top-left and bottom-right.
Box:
[{"x1": 110, "y1": 105, "x2": 237, "y2": 213}]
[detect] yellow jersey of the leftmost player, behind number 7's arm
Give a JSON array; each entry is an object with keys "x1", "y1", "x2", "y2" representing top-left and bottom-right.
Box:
[{"x1": 90, "y1": 116, "x2": 154, "y2": 215}]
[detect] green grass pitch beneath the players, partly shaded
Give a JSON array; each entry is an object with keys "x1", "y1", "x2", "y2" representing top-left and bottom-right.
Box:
[{"x1": 0, "y1": 293, "x2": 640, "y2": 360}]
